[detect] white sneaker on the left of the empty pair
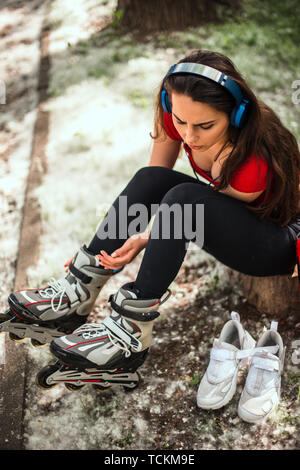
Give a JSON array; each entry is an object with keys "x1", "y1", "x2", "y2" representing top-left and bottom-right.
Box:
[{"x1": 197, "y1": 312, "x2": 255, "y2": 410}]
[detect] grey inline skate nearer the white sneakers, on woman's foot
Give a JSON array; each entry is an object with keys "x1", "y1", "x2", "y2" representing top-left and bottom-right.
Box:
[{"x1": 36, "y1": 283, "x2": 171, "y2": 391}]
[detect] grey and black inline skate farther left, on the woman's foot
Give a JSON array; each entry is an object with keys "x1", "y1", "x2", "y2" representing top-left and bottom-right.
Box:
[{"x1": 0, "y1": 245, "x2": 120, "y2": 346}]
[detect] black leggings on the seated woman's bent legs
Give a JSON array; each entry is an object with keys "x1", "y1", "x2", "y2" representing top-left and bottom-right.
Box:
[{"x1": 88, "y1": 166, "x2": 296, "y2": 298}]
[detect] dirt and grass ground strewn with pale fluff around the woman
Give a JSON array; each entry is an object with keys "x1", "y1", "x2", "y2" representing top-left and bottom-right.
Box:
[{"x1": 0, "y1": 0, "x2": 300, "y2": 450}]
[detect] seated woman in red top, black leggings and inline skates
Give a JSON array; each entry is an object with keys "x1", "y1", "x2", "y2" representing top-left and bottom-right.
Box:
[{"x1": 2, "y1": 51, "x2": 300, "y2": 410}]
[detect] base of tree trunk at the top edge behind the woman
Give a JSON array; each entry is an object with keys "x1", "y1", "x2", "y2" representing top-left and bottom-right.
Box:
[{"x1": 115, "y1": 0, "x2": 241, "y2": 34}]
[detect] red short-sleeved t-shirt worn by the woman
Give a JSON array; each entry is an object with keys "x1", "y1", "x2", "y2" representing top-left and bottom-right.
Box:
[{"x1": 163, "y1": 113, "x2": 268, "y2": 203}]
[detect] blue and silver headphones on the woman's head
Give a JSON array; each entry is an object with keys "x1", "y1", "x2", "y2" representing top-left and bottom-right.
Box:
[{"x1": 161, "y1": 62, "x2": 249, "y2": 128}]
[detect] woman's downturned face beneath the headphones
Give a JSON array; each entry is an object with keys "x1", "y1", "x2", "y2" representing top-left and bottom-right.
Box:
[{"x1": 172, "y1": 92, "x2": 229, "y2": 152}]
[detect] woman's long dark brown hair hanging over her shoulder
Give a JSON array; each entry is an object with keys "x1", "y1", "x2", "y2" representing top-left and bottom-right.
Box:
[{"x1": 153, "y1": 50, "x2": 300, "y2": 226}]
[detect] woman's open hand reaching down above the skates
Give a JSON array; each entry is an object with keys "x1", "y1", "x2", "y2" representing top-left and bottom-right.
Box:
[{"x1": 96, "y1": 232, "x2": 150, "y2": 269}]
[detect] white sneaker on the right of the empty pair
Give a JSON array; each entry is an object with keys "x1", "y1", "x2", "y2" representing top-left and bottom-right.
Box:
[{"x1": 238, "y1": 322, "x2": 285, "y2": 423}]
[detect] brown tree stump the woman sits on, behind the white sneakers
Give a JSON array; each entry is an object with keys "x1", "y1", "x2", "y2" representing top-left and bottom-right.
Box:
[{"x1": 237, "y1": 273, "x2": 300, "y2": 318}]
